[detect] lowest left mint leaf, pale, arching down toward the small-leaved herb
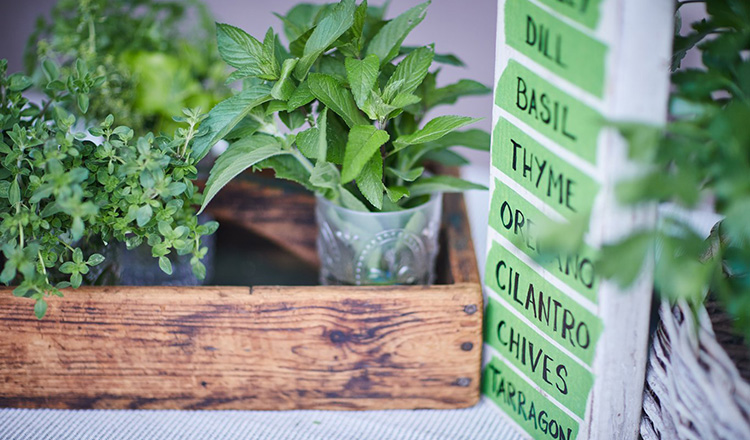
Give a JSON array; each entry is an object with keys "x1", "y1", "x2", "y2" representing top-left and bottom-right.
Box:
[{"x1": 198, "y1": 135, "x2": 289, "y2": 214}]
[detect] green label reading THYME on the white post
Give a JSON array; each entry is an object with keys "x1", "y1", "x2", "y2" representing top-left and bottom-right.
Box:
[{"x1": 492, "y1": 118, "x2": 599, "y2": 219}]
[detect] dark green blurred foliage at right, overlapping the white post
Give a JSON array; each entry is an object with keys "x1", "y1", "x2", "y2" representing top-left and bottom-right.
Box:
[{"x1": 600, "y1": 0, "x2": 750, "y2": 340}]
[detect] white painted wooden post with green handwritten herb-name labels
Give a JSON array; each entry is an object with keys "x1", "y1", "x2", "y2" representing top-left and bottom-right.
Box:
[{"x1": 483, "y1": 0, "x2": 674, "y2": 439}]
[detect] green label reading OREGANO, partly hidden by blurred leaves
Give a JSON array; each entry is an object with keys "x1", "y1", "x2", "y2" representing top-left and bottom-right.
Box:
[{"x1": 490, "y1": 180, "x2": 599, "y2": 303}]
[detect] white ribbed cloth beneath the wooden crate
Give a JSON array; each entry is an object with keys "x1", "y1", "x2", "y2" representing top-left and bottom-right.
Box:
[{"x1": 0, "y1": 398, "x2": 524, "y2": 440}]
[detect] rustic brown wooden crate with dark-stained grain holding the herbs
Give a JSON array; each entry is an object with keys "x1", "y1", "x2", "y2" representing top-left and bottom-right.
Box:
[{"x1": 0, "y1": 177, "x2": 483, "y2": 410}]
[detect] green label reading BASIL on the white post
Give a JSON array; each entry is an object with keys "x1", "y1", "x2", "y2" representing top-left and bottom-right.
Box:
[{"x1": 495, "y1": 60, "x2": 603, "y2": 164}]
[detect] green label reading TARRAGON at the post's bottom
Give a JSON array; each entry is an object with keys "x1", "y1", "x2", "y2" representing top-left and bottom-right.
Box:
[{"x1": 482, "y1": 358, "x2": 579, "y2": 440}]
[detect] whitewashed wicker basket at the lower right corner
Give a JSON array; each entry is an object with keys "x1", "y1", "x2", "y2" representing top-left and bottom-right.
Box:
[{"x1": 641, "y1": 302, "x2": 750, "y2": 440}]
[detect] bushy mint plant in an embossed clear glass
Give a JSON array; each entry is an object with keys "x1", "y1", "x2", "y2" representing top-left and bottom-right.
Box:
[{"x1": 193, "y1": 0, "x2": 490, "y2": 285}]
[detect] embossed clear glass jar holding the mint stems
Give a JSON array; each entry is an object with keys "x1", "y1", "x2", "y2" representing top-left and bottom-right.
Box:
[{"x1": 315, "y1": 194, "x2": 443, "y2": 286}]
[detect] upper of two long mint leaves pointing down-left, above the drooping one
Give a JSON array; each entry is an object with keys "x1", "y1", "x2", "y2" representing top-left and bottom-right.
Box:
[{"x1": 192, "y1": 84, "x2": 272, "y2": 162}]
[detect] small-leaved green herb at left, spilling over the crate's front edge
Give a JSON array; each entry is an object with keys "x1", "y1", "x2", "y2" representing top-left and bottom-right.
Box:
[{"x1": 0, "y1": 60, "x2": 218, "y2": 319}]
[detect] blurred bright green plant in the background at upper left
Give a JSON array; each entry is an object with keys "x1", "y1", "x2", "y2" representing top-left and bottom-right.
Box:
[{"x1": 26, "y1": 0, "x2": 229, "y2": 136}]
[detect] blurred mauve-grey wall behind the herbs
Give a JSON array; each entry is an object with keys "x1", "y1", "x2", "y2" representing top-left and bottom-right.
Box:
[{"x1": 0, "y1": 0, "x2": 497, "y2": 134}]
